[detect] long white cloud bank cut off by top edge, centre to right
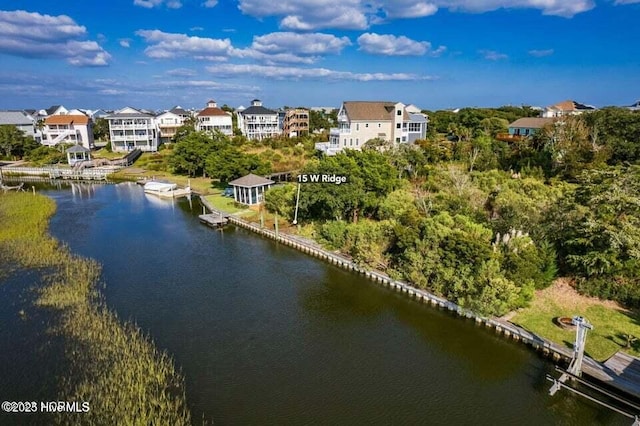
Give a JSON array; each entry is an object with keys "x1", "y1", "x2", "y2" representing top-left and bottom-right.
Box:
[{"x1": 239, "y1": 0, "x2": 596, "y2": 31}]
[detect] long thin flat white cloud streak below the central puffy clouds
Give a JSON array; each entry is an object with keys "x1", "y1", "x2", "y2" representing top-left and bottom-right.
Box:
[{"x1": 206, "y1": 64, "x2": 435, "y2": 81}]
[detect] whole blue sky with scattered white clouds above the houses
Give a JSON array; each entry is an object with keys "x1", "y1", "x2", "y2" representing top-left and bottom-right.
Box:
[{"x1": 0, "y1": 0, "x2": 640, "y2": 109}]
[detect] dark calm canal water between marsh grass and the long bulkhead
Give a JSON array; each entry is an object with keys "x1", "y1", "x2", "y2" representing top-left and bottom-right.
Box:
[{"x1": 0, "y1": 184, "x2": 631, "y2": 425}]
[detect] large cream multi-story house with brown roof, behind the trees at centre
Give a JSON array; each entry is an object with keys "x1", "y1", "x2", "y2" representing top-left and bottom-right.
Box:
[{"x1": 316, "y1": 101, "x2": 428, "y2": 155}]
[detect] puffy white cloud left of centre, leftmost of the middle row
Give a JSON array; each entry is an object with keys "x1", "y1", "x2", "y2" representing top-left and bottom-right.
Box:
[{"x1": 136, "y1": 30, "x2": 232, "y2": 61}]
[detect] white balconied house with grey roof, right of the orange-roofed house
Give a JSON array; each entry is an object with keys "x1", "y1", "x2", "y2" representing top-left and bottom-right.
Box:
[{"x1": 105, "y1": 107, "x2": 160, "y2": 152}]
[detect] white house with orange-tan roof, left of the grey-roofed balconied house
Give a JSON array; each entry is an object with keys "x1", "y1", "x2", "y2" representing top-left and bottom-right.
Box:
[{"x1": 42, "y1": 114, "x2": 93, "y2": 149}]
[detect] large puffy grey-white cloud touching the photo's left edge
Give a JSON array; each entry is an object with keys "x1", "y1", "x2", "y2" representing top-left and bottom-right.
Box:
[{"x1": 0, "y1": 10, "x2": 111, "y2": 66}]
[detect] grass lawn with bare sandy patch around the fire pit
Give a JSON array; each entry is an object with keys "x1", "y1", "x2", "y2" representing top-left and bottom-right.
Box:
[{"x1": 511, "y1": 285, "x2": 640, "y2": 361}]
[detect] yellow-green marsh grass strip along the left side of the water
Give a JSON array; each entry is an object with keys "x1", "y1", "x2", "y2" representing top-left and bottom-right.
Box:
[{"x1": 0, "y1": 193, "x2": 190, "y2": 425}]
